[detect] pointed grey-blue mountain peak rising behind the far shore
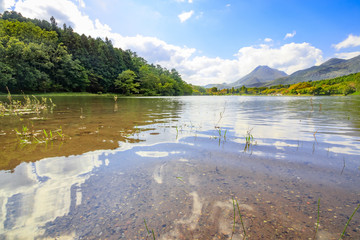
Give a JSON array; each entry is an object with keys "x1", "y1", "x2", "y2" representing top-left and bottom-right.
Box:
[{"x1": 229, "y1": 66, "x2": 288, "y2": 88}]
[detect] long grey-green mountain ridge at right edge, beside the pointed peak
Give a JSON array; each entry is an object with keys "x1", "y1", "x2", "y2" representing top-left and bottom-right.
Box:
[{"x1": 265, "y1": 55, "x2": 360, "y2": 86}]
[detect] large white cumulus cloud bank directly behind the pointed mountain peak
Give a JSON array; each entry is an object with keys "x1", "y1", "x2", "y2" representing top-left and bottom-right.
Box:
[{"x1": 176, "y1": 43, "x2": 323, "y2": 85}]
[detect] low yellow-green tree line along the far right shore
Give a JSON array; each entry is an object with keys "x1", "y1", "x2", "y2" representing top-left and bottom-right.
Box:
[{"x1": 202, "y1": 73, "x2": 360, "y2": 96}]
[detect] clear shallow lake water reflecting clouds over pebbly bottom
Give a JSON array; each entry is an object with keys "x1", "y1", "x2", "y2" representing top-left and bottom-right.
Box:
[{"x1": 0, "y1": 96, "x2": 360, "y2": 239}]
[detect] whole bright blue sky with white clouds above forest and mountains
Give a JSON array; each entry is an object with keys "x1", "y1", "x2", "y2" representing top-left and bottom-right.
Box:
[{"x1": 0, "y1": 0, "x2": 360, "y2": 85}]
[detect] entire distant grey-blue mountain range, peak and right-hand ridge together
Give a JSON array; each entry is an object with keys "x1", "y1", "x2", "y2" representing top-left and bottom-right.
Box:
[{"x1": 205, "y1": 55, "x2": 360, "y2": 89}]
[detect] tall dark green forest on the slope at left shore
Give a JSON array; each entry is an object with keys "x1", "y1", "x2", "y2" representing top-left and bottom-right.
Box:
[{"x1": 0, "y1": 11, "x2": 192, "y2": 96}]
